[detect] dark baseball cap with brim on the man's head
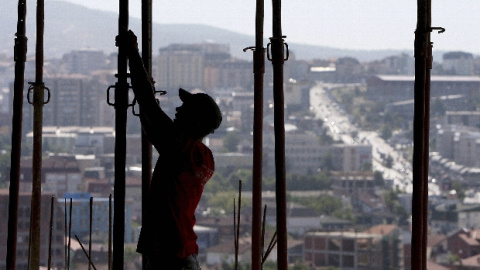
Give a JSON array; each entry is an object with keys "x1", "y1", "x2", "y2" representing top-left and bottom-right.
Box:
[{"x1": 178, "y1": 88, "x2": 222, "y2": 130}]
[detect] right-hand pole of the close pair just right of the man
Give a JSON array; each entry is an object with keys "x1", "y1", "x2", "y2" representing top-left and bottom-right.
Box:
[{"x1": 270, "y1": 0, "x2": 288, "y2": 270}]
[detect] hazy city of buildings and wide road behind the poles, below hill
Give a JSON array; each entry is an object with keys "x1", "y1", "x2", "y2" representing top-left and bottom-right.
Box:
[{"x1": 0, "y1": 35, "x2": 480, "y2": 269}]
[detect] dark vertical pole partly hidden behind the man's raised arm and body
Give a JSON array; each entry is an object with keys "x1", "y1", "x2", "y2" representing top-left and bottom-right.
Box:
[{"x1": 140, "y1": 0, "x2": 152, "y2": 270}]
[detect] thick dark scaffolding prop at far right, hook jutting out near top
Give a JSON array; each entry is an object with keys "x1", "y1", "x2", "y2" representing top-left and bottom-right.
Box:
[{"x1": 411, "y1": 0, "x2": 445, "y2": 270}]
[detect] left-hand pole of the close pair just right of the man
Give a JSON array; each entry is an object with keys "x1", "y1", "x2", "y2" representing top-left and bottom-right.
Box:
[{"x1": 252, "y1": 0, "x2": 265, "y2": 270}]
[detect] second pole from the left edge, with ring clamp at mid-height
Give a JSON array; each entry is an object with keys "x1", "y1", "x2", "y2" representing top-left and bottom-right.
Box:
[{"x1": 29, "y1": 0, "x2": 45, "y2": 269}]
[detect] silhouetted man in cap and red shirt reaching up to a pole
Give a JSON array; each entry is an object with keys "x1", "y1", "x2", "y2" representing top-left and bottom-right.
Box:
[{"x1": 118, "y1": 31, "x2": 222, "y2": 270}]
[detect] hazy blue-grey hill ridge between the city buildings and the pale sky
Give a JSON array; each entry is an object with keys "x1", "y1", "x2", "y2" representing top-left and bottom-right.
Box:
[{"x1": 0, "y1": 0, "x2": 439, "y2": 61}]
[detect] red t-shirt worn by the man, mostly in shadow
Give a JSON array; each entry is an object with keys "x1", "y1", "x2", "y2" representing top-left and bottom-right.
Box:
[{"x1": 138, "y1": 135, "x2": 215, "y2": 258}]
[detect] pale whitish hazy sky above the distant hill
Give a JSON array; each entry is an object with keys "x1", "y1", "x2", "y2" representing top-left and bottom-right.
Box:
[{"x1": 62, "y1": 0, "x2": 480, "y2": 53}]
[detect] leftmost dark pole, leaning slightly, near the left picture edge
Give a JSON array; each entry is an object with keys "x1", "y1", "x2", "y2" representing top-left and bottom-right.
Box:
[{"x1": 6, "y1": 0, "x2": 27, "y2": 270}]
